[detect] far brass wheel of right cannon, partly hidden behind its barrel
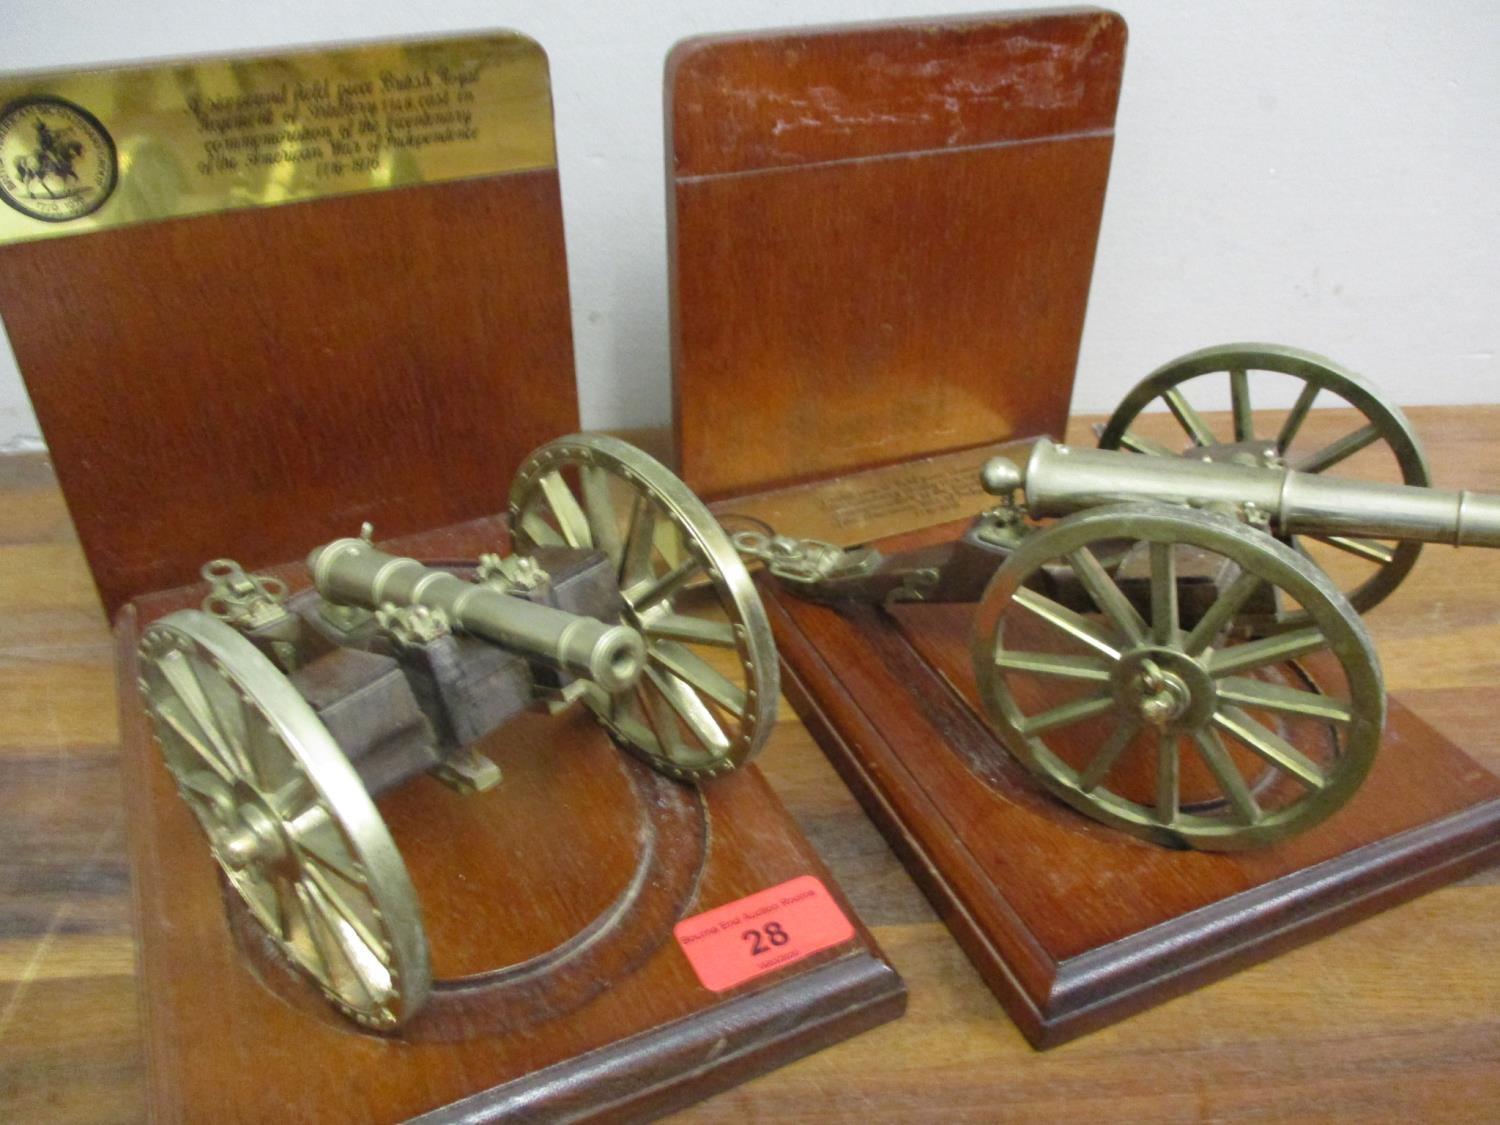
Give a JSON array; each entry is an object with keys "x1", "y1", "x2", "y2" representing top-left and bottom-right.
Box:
[{"x1": 1100, "y1": 344, "x2": 1431, "y2": 629}]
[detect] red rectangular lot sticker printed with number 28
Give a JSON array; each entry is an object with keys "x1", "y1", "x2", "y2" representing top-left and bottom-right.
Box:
[{"x1": 672, "y1": 875, "x2": 854, "y2": 992}]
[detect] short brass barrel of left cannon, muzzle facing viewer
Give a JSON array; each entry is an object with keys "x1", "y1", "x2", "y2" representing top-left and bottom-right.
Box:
[{"x1": 308, "y1": 539, "x2": 645, "y2": 692}]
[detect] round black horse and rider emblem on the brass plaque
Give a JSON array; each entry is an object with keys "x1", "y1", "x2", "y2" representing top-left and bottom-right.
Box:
[{"x1": 0, "y1": 98, "x2": 117, "y2": 222}]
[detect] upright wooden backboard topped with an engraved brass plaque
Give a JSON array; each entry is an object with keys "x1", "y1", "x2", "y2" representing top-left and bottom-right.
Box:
[{"x1": 0, "y1": 35, "x2": 578, "y2": 617}]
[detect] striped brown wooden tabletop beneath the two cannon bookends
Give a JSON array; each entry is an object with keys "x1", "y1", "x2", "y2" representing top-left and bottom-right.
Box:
[{"x1": 0, "y1": 407, "x2": 1500, "y2": 1122}]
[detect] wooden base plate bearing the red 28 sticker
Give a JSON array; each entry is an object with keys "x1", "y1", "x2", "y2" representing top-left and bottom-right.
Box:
[{"x1": 116, "y1": 521, "x2": 905, "y2": 1122}]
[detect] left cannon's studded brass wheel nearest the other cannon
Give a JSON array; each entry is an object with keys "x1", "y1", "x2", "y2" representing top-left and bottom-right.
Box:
[{"x1": 510, "y1": 434, "x2": 779, "y2": 779}]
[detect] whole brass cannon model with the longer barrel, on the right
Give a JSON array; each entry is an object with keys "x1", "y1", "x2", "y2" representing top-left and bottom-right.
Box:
[{"x1": 737, "y1": 345, "x2": 1500, "y2": 851}]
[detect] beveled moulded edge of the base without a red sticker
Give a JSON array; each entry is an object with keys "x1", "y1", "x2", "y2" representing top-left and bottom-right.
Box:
[{"x1": 762, "y1": 582, "x2": 1500, "y2": 1050}]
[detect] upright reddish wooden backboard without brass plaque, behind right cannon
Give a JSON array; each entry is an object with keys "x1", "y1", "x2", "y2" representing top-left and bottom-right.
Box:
[{"x1": 668, "y1": 9, "x2": 1125, "y2": 497}]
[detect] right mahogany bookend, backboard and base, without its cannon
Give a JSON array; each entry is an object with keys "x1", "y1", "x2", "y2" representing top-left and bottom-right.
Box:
[{"x1": 668, "y1": 9, "x2": 1500, "y2": 1047}]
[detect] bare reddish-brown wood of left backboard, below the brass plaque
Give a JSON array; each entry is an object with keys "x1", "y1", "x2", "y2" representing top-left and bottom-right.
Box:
[{"x1": 0, "y1": 170, "x2": 578, "y2": 614}]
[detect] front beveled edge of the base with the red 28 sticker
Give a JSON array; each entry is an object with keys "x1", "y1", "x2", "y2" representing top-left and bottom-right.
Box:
[{"x1": 413, "y1": 950, "x2": 906, "y2": 1125}]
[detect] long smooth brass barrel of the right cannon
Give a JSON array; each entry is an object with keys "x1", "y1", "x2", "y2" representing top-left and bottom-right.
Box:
[{"x1": 981, "y1": 438, "x2": 1500, "y2": 548}]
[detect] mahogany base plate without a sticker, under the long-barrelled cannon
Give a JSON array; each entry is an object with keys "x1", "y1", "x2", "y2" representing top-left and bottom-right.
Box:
[{"x1": 762, "y1": 533, "x2": 1500, "y2": 1047}]
